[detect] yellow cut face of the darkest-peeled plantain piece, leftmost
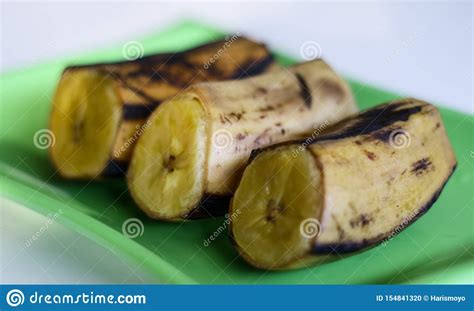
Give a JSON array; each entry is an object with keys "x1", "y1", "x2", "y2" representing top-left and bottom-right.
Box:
[{"x1": 50, "y1": 69, "x2": 121, "y2": 178}]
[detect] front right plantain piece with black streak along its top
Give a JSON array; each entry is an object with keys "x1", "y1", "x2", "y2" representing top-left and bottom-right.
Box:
[{"x1": 229, "y1": 99, "x2": 456, "y2": 270}]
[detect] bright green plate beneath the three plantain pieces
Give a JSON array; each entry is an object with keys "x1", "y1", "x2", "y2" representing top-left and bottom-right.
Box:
[{"x1": 0, "y1": 22, "x2": 474, "y2": 284}]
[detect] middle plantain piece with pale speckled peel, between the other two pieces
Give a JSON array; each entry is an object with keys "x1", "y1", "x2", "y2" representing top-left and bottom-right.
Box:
[{"x1": 128, "y1": 60, "x2": 357, "y2": 220}]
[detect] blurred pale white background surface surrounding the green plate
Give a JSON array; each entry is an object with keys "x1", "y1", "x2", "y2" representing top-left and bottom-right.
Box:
[{"x1": 0, "y1": 1, "x2": 474, "y2": 283}]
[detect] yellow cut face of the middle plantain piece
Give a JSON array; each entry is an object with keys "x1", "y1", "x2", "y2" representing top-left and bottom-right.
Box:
[{"x1": 128, "y1": 94, "x2": 207, "y2": 220}]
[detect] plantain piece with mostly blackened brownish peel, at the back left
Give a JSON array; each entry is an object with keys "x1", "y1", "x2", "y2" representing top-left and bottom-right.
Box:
[{"x1": 50, "y1": 36, "x2": 278, "y2": 178}]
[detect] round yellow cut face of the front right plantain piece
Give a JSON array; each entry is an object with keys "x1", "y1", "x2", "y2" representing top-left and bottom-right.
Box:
[{"x1": 231, "y1": 146, "x2": 322, "y2": 269}]
